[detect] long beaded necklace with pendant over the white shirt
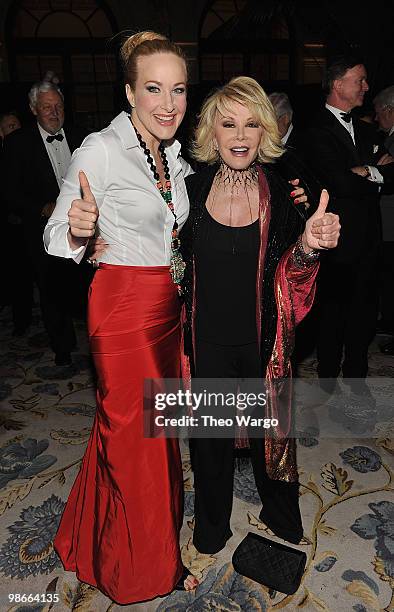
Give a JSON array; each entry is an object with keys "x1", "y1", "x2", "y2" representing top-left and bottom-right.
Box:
[{"x1": 132, "y1": 123, "x2": 186, "y2": 295}]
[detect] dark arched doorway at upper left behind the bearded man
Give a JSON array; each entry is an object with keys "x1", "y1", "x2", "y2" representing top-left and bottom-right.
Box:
[{"x1": 6, "y1": 0, "x2": 119, "y2": 128}]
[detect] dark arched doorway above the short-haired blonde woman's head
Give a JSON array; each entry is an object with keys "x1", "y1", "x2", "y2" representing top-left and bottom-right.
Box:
[{"x1": 200, "y1": 0, "x2": 328, "y2": 88}]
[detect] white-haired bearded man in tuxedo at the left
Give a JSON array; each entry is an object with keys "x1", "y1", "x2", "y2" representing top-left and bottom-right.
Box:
[{"x1": 2, "y1": 81, "x2": 84, "y2": 365}]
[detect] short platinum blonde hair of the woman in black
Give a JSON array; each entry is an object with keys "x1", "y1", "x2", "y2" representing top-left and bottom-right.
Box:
[{"x1": 191, "y1": 76, "x2": 284, "y2": 164}]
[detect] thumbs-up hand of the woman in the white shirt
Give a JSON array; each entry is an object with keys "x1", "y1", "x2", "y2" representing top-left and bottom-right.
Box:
[{"x1": 68, "y1": 171, "x2": 99, "y2": 244}]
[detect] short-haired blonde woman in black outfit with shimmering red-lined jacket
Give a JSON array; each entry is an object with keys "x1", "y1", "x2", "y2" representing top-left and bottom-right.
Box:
[{"x1": 182, "y1": 77, "x2": 340, "y2": 554}]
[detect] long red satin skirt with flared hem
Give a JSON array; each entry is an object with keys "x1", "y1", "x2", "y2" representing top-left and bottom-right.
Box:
[{"x1": 54, "y1": 264, "x2": 183, "y2": 604}]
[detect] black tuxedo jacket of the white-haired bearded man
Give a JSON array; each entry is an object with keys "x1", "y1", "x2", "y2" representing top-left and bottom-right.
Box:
[{"x1": 1, "y1": 123, "x2": 86, "y2": 229}]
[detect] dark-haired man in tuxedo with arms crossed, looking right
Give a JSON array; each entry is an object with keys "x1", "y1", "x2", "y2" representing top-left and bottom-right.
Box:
[{"x1": 302, "y1": 56, "x2": 392, "y2": 395}]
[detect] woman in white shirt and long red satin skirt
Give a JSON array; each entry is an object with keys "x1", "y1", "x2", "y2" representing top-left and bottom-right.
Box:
[{"x1": 44, "y1": 32, "x2": 198, "y2": 604}]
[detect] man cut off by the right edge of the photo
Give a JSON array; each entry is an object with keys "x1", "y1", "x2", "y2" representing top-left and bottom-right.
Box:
[{"x1": 373, "y1": 85, "x2": 394, "y2": 355}]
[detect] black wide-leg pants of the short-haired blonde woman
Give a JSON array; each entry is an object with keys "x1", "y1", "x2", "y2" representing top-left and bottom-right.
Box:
[{"x1": 191, "y1": 340, "x2": 303, "y2": 554}]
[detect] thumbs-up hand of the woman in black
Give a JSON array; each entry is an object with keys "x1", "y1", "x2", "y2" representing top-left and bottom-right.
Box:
[{"x1": 302, "y1": 189, "x2": 341, "y2": 253}]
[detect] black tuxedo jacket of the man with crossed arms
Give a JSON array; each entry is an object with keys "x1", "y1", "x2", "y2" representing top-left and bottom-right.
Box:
[{"x1": 299, "y1": 108, "x2": 381, "y2": 263}]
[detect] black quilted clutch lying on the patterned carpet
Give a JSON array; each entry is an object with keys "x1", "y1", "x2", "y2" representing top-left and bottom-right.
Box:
[{"x1": 232, "y1": 532, "x2": 306, "y2": 595}]
